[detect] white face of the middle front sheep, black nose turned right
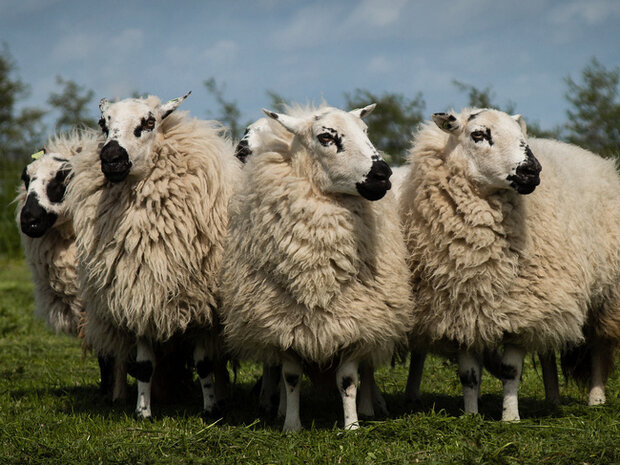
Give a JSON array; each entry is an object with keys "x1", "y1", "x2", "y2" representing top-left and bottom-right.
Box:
[{"x1": 263, "y1": 104, "x2": 392, "y2": 200}]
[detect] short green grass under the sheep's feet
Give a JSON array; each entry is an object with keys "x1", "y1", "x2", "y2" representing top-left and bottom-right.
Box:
[{"x1": 0, "y1": 260, "x2": 620, "y2": 465}]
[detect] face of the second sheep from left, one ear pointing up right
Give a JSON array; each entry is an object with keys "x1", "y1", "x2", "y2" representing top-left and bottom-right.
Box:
[{"x1": 99, "y1": 92, "x2": 190, "y2": 182}]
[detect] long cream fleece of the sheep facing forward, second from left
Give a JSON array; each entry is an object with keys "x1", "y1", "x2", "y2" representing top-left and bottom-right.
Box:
[{"x1": 67, "y1": 112, "x2": 240, "y2": 356}]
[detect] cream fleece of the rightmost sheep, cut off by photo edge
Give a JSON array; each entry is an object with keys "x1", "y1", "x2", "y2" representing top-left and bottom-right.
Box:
[{"x1": 400, "y1": 125, "x2": 620, "y2": 351}]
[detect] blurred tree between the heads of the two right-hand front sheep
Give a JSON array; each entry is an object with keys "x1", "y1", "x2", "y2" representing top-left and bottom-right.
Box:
[{"x1": 344, "y1": 89, "x2": 426, "y2": 165}]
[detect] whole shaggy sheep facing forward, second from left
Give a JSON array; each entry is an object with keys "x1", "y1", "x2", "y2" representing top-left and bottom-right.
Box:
[{"x1": 67, "y1": 93, "x2": 240, "y2": 419}]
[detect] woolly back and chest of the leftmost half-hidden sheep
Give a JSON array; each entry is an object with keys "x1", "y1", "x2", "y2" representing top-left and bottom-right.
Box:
[{"x1": 16, "y1": 130, "x2": 101, "y2": 335}]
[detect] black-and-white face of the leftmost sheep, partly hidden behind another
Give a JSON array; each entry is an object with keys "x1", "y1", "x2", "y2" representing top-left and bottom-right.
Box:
[{"x1": 19, "y1": 153, "x2": 70, "y2": 238}]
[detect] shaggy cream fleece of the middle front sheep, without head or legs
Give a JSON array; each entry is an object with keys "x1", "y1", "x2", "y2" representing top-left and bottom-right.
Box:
[{"x1": 221, "y1": 139, "x2": 411, "y2": 364}]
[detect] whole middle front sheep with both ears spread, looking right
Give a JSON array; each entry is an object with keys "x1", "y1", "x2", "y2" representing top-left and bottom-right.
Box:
[{"x1": 218, "y1": 104, "x2": 411, "y2": 431}]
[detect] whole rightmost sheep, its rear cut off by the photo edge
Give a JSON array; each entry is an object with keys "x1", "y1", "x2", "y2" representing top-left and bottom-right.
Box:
[{"x1": 400, "y1": 109, "x2": 620, "y2": 421}]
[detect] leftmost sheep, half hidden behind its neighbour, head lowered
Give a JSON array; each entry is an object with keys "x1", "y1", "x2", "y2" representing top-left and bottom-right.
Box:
[{"x1": 15, "y1": 129, "x2": 122, "y2": 393}]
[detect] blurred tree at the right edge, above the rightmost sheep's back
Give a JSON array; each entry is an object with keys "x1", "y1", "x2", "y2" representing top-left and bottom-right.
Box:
[{"x1": 565, "y1": 58, "x2": 620, "y2": 156}]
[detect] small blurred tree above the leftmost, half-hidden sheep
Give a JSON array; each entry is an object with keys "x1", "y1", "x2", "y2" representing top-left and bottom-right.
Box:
[{"x1": 47, "y1": 76, "x2": 97, "y2": 130}]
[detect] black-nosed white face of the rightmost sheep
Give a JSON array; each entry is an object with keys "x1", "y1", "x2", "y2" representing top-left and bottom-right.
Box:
[{"x1": 433, "y1": 109, "x2": 541, "y2": 194}]
